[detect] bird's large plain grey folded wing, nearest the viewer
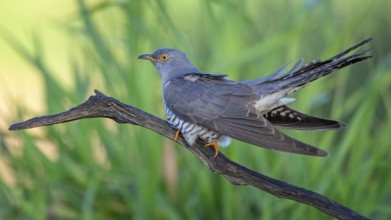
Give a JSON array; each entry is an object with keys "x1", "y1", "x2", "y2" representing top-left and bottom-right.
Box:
[{"x1": 163, "y1": 74, "x2": 327, "y2": 156}]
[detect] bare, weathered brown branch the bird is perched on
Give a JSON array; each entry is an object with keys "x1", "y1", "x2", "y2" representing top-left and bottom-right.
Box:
[{"x1": 9, "y1": 90, "x2": 368, "y2": 219}]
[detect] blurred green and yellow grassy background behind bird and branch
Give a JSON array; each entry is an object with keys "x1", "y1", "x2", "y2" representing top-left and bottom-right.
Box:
[{"x1": 0, "y1": 0, "x2": 391, "y2": 220}]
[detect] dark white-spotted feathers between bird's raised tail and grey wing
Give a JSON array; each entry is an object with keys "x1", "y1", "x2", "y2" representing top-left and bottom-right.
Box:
[{"x1": 264, "y1": 105, "x2": 347, "y2": 130}]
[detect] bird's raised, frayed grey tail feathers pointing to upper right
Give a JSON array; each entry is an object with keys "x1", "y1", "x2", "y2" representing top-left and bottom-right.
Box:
[{"x1": 253, "y1": 38, "x2": 372, "y2": 96}]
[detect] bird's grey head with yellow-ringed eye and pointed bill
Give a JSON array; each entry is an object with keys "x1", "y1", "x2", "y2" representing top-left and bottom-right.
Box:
[{"x1": 138, "y1": 48, "x2": 202, "y2": 82}]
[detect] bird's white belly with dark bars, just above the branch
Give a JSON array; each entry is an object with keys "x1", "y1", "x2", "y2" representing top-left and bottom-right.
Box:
[{"x1": 165, "y1": 105, "x2": 231, "y2": 147}]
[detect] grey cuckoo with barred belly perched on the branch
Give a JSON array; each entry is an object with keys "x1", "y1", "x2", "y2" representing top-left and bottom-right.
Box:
[{"x1": 138, "y1": 38, "x2": 372, "y2": 157}]
